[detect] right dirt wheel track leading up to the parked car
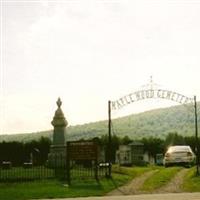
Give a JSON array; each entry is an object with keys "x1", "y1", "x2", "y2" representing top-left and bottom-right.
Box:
[{"x1": 153, "y1": 169, "x2": 189, "y2": 193}]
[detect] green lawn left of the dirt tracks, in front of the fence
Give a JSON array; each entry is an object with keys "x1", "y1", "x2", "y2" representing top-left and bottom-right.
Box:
[{"x1": 0, "y1": 166, "x2": 151, "y2": 200}]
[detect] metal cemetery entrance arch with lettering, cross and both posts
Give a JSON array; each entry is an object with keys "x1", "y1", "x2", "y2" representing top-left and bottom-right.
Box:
[{"x1": 108, "y1": 77, "x2": 199, "y2": 175}]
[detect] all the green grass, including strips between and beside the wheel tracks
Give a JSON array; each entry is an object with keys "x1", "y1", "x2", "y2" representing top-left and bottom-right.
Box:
[{"x1": 0, "y1": 165, "x2": 200, "y2": 200}]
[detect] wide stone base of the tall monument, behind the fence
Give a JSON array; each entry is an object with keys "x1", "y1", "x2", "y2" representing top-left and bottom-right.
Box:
[{"x1": 47, "y1": 145, "x2": 67, "y2": 169}]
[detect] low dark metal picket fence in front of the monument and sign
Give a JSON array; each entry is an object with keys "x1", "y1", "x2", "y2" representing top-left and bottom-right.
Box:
[{"x1": 0, "y1": 158, "x2": 108, "y2": 182}]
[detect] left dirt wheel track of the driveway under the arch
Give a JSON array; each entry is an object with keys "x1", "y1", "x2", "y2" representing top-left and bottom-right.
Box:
[{"x1": 107, "y1": 170, "x2": 158, "y2": 196}]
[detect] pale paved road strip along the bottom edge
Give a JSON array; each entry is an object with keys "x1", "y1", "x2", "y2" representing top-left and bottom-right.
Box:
[{"x1": 40, "y1": 193, "x2": 200, "y2": 200}]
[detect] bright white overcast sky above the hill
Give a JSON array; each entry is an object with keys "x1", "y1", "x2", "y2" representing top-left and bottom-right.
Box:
[{"x1": 0, "y1": 0, "x2": 200, "y2": 134}]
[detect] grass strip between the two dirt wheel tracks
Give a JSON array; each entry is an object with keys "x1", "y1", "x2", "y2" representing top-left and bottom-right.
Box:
[{"x1": 141, "y1": 167, "x2": 182, "y2": 192}]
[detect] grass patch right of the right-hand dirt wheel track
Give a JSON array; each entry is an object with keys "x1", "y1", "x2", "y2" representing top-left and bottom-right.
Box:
[{"x1": 182, "y1": 167, "x2": 200, "y2": 192}]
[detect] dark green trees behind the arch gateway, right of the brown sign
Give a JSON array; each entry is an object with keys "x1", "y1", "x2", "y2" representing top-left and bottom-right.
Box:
[{"x1": 93, "y1": 132, "x2": 200, "y2": 163}]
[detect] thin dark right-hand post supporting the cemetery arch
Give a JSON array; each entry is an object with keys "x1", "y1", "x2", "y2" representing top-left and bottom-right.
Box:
[{"x1": 194, "y1": 96, "x2": 199, "y2": 176}]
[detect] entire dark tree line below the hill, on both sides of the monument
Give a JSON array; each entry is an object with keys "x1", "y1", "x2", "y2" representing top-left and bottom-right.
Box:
[{"x1": 0, "y1": 132, "x2": 200, "y2": 166}]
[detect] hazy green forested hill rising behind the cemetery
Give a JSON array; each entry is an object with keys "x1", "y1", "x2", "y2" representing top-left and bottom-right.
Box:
[{"x1": 0, "y1": 103, "x2": 200, "y2": 142}]
